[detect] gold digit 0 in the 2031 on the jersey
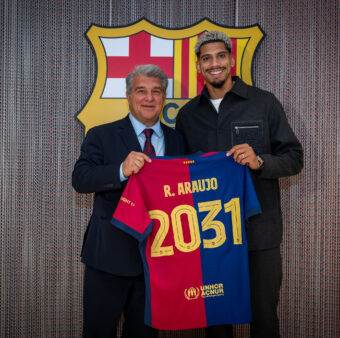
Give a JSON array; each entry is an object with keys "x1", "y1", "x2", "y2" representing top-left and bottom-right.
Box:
[{"x1": 171, "y1": 204, "x2": 201, "y2": 252}]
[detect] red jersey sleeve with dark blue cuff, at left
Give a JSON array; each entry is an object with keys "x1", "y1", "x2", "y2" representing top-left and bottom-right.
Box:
[{"x1": 111, "y1": 175, "x2": 152, "y2": 241}]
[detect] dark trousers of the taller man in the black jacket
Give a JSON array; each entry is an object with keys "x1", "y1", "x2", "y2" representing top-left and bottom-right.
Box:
[{"x1": 206, "y1": 247, "x2": 282, "y2": 338}]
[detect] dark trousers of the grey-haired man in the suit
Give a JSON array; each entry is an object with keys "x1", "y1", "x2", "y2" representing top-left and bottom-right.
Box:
[{"x1": 83, "y1": 265, "x2": 157, "y2": 338}]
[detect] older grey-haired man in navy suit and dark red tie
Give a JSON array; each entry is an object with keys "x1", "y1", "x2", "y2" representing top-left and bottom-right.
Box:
[{"x1": 72, "y1": 65, "x2": 184, "y2": 338}]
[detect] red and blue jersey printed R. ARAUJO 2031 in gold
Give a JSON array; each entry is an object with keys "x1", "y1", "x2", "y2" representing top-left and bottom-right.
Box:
[{"x1": 112, "y1": 153, "x2": 261, "y2": 330}]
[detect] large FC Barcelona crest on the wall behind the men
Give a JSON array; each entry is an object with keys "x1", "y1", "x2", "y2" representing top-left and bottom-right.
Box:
[{"x1": 77, "y1": 19, "x2": 264, "y2": 132}]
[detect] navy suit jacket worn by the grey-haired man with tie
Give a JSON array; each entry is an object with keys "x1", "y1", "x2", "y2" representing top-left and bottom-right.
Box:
[{"x1": 72, "y1": 116, "x2": 185, "y2": 276}]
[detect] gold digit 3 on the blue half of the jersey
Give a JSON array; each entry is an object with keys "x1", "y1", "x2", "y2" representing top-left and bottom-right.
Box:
[{"x1": 198, "y1": 200, "x2": 227, "y2": 248}]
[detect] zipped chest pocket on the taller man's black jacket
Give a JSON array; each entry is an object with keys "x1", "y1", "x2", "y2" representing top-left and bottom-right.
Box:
[{"x1": 231, "y1": 121, "x2": 264, "y2": 154}]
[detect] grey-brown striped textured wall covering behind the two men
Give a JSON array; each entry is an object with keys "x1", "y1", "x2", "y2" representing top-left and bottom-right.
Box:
[{"x1": 0, "y1": 0, "x2": 340, "y2": 338}]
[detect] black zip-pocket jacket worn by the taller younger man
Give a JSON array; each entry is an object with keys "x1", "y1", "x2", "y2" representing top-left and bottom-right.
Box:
[{"x1": 176, "y1": 77, "x2": 303, "y2": 250}]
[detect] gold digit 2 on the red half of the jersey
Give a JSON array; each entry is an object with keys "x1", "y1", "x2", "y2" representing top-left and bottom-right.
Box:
[{"x1": 149, "y1": 210, "x2": 174, "y2": 257}]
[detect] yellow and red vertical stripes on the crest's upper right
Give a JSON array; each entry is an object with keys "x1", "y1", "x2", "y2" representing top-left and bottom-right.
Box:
[{"x1": 173, "y1": 36, "x2": 248, "y2": 99}]
